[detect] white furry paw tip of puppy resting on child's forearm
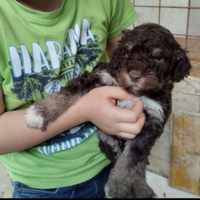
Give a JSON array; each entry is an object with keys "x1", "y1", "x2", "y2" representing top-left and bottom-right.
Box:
[{"x1": 24, "y1": 105, "x2": 45, "y2": 130}]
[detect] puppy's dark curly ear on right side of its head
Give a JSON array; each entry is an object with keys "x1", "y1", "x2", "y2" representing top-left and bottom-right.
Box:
[{"x1": 172, "y1": 49, "x2": 192, "y2": 82}]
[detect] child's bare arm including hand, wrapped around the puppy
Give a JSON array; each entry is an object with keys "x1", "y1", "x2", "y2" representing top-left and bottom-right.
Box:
[{"x1": 0, "y1": 86, "x2": 145, "y2": 155}]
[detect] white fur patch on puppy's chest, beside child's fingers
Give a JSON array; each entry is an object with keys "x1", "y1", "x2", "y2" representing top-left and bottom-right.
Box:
[{"x1": 117, "y1": 96, "x2": 164, "y2": 122}]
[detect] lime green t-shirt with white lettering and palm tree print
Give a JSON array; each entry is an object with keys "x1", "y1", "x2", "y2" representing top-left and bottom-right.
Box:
[{"x1": 0, "y1": 0, "x2": 137, "y2": 188}]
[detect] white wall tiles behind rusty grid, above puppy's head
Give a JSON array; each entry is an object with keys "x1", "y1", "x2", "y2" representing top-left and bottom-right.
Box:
[{"x1": 132, "y1": 0, "x2": 200, "y2": 36}]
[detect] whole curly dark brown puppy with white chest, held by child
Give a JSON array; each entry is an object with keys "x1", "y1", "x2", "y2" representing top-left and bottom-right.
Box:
[{"x1": 25, "y1": 23, "x2": 191, "y2": 198}]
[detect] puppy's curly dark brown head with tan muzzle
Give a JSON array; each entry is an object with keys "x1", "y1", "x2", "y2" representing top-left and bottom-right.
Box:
[{"x1": 110, "y1": 23, "x2": 191, "y2": 95}]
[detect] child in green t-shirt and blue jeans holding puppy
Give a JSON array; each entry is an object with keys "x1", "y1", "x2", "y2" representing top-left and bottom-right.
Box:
[{"x1": 0, "y1": 0, "x2": 145, "y2": 198}]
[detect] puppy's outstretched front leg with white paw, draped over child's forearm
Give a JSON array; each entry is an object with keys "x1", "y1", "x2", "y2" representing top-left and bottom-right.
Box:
[{"x1": 25, "y1": 67, "x2": 116, "y2": 131}]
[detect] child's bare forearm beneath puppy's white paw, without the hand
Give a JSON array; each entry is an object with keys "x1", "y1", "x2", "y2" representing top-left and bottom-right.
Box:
[{"x1": 0, "y1": 102, "x2": 84, "y2": 155}]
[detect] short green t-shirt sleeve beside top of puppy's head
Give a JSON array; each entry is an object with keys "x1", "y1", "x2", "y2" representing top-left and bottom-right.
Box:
[{"x1": 108, "y1": 0, "x2": 137, "y2": 39}]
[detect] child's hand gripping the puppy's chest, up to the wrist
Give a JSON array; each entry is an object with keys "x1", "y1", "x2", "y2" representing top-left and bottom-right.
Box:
[{"x1": 78, "y1": 86, "x2": 145, "y2": 139}]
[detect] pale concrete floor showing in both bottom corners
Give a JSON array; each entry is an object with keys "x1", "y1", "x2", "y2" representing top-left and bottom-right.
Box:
[{"x1": 0, "y1": 160, "x2": 200, "y2": 198}]
